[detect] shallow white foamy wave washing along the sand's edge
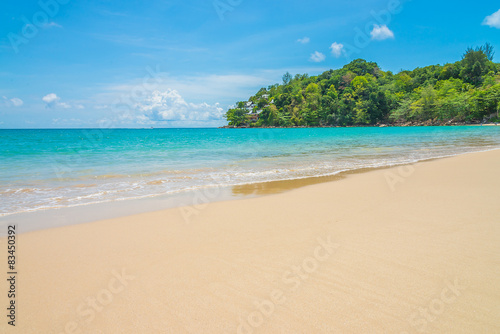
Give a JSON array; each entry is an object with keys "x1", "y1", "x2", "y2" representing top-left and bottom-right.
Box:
[{"x1": 0, "y1": 146, "x2": 498, "y2": 216}]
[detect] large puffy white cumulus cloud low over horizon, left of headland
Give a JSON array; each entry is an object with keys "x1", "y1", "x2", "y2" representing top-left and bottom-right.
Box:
[{"x1": 136, "y1": 89, "x2": 223, "y2": 123}]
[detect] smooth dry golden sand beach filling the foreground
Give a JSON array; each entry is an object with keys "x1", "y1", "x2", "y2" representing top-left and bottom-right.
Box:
[{"x1": 0, "y1": 150, "x2": 500, "y2": 334}]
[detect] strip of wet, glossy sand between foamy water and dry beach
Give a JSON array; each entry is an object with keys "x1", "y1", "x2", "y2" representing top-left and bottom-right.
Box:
[{"x1": 0, "y1": 148, "x2": 500, "y2": 235}]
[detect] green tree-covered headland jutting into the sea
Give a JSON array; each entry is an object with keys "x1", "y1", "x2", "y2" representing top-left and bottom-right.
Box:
[{"x1": 226, "y1": 44, "x2": 500, "y2": 127}]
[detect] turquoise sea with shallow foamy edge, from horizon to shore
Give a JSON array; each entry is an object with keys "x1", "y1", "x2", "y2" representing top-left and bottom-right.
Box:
[{"x1": 0, "y1": 126, "x2": 500, "y2": 216}]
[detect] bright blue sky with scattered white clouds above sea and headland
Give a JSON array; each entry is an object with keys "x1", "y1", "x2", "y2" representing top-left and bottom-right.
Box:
[{"x1": 0, "y1": 0, "x2": 500, "y2": 128}]
